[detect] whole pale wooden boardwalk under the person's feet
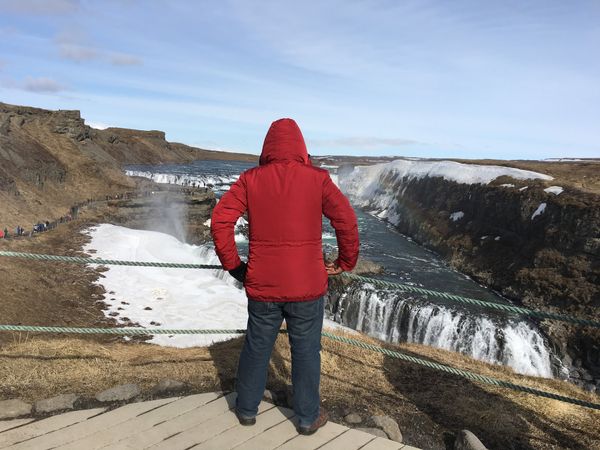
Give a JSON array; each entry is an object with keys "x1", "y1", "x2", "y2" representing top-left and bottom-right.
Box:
[{"x1": 0, "y1": 393, "x2": 414, "y2": 450}]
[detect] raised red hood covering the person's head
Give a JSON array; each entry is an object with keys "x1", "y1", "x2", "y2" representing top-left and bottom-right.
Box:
[{"x1": 259, "y1": 119, "x2": 310, "y2": 166}]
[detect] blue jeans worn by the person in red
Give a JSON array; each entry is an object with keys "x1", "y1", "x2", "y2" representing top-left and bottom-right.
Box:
[{"x1": 236, "y1": 297, "x2": 324, "y2": 426}]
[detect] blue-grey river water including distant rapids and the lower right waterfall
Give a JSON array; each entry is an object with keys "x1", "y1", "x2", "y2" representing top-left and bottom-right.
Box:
[{"x1": 126, "y1": 161, "x2": 564, "y2": 377}]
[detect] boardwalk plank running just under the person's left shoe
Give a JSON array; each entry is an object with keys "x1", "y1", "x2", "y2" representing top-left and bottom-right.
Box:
[{"x1": 194, "y1": 408, "x2": 294, "y2": 450}]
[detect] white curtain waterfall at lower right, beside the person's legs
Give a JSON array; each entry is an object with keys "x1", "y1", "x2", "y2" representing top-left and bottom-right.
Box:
[{"x1": 327, "y1": 283, "x2": 553, "y2": 378}]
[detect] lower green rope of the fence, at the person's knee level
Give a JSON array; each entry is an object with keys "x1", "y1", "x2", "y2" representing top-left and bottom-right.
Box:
[{"x1": 0, "y1": 325, "x2": 600, "y2": 410}]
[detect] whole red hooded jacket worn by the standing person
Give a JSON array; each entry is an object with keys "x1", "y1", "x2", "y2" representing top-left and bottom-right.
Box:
[{"x1": 211, "y1": 119, "x2": 358, "y2": 301}]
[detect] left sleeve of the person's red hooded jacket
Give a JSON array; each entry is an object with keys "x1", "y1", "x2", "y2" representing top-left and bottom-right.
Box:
[{"x1": 210, "y1": 173, "x2": 247, "y2": 270}]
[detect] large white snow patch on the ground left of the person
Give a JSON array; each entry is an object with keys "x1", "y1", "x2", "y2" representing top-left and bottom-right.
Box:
[{"x1": 84, "y1": 224, "x2": 350, "y2": 347}]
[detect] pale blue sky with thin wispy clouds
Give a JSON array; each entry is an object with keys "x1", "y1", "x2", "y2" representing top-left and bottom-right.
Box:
[{"x1": 0, "y1": 0, "x2": 600, "y2": 159}]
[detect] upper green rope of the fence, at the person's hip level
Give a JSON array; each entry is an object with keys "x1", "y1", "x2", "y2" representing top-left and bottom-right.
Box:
[{"x1": 0, "y1": 251, "x2": 600, "y2": 328}]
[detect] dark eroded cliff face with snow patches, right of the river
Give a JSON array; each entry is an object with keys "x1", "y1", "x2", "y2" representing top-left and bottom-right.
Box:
[{"x1": 339, "y1": 164, "x2": 600, "y2": 389}]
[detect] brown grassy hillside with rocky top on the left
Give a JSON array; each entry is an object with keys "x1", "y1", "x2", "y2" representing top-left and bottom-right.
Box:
[{"x1": 0, "y1": 103, "x2": 257, "y2": 230}]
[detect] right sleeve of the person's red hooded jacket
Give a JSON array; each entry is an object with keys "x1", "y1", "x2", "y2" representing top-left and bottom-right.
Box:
[{"x1": 323, "y1": 174, "x2": 359, "y2": 271}]
